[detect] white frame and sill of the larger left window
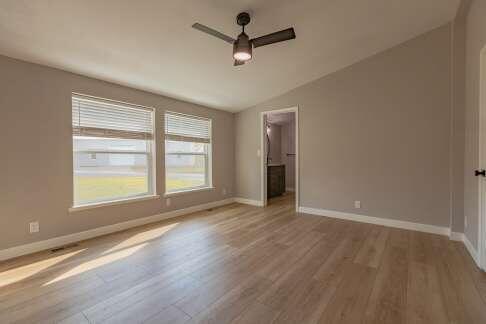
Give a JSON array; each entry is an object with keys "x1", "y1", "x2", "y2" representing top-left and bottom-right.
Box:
[{"x1": 69, "y1": 92, "x2": 156, "y2": 211}]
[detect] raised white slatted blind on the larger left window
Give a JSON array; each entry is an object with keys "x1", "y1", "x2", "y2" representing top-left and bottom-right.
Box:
[{"x1": 72, "y1": 95, "x2": 154, "y2": 139}]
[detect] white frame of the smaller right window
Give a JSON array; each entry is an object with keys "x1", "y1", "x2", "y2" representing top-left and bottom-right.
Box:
[{"x1": 163, "y1": 111, "x2": 214, "y2": 197}]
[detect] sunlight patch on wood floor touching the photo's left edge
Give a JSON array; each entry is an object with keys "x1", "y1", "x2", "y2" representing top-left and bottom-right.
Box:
[{"x1": 0, "y1": 249, "x2": 86, "y2": 287}]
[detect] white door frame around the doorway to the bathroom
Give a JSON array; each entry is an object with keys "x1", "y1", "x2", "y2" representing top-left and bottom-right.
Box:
[{"x1": 260, "y1": 106, "x2": 300, "y2": 211}]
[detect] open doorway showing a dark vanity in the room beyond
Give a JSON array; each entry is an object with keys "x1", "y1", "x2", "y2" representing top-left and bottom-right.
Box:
[{"x1": 260, "y1": 107, "x2": 299, "y2": 211}]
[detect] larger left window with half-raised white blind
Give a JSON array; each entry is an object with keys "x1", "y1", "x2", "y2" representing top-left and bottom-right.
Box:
[{"x1": 72, "y1": 95, "x2": 155, "y2": 206}]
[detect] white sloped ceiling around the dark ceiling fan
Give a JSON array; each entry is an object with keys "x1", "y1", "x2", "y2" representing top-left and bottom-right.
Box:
[{"x1": 0, "y1": 0, "x2": 460, "y2": 111}]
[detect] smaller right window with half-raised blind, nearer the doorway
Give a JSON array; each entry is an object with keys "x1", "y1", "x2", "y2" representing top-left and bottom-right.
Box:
[{"x1": 165, "y1": 112, "x2": 212, "y2": 193}]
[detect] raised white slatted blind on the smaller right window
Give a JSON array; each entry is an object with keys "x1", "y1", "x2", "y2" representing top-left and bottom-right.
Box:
[{"x1": 165, "y1": 112, "x2": 211, "y2": 143}]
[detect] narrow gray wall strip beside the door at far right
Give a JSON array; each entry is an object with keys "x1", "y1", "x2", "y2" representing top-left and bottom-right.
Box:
[{"x1": 464, "y1": 0, "x2": 486, "y2": 247}]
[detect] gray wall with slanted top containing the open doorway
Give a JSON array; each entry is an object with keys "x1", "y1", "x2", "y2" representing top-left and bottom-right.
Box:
[{"x1": 235, "y1": 25, "x2": 452, "y2": 227}]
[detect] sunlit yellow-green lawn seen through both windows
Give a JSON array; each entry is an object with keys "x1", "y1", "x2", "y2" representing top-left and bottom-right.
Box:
[{"x1": 74, "y1": 176, "x2": 205, "y2": 204}]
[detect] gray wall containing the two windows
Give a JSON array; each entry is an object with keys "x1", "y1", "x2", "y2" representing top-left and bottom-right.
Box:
[{"x1": 0, "y1": 56, "x2": 234, "y2": 249}]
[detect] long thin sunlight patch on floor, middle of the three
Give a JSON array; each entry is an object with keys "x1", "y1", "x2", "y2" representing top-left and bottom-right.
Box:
[{"x1": 43, "y1": 243, "x2": 148, "y2": 286}]
